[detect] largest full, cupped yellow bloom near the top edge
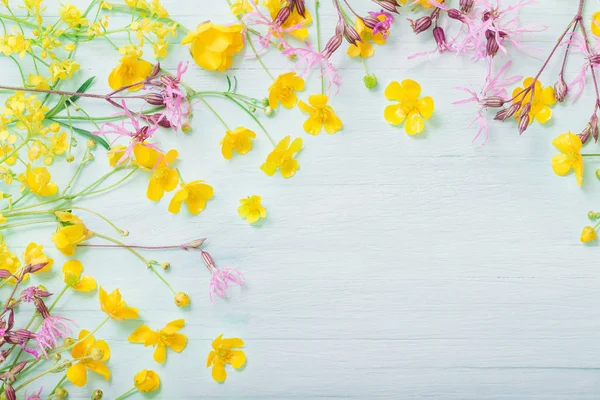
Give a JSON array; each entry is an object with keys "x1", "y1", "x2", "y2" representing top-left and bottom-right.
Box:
[{"x1": 181, "y1": 21, "x2": 244, "y2": 72}]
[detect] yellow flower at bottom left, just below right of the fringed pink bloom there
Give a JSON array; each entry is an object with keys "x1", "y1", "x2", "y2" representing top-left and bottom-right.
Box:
[{"x1": 67, "y1": 329, "x2": 110, "y2": 387}]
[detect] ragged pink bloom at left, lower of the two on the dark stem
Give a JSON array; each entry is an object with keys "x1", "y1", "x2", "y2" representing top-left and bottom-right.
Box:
[{"x1": 92, "y1": 100, "x2": 160, "y2": 164}]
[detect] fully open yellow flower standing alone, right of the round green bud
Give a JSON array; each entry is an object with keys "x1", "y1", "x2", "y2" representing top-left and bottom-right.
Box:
[{"x1": 384, "y1": 79, "x2": 434, "y2": 135}]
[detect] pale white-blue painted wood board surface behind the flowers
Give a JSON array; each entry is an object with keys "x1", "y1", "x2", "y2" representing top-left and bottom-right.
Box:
[{"x1": 2, "y1": 0, "x2": 600, "y2": 400}]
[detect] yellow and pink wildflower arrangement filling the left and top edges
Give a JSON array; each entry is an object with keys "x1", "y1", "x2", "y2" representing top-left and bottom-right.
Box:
[{"x1": 0, "y1": 0, "x2": 600, "y2": 400}]
